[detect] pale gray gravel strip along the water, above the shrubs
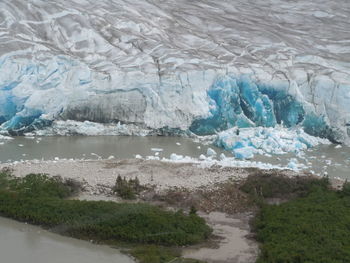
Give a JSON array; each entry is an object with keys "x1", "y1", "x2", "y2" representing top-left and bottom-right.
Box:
[{"x1": 0, "y1": 159, "x2": 256, "y2": 193}]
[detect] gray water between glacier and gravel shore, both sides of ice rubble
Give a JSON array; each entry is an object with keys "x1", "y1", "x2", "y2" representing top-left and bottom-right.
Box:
[{"x1": 0, "y1": 136, "x2": 350, "y2": 182}]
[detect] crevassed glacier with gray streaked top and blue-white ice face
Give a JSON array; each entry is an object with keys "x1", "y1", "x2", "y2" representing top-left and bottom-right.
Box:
[{"x1": 0, "y1": 0, "x2": 350, "y2": 142}]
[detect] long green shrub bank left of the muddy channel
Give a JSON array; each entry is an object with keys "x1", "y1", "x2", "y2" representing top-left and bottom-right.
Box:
[{"x1": 0, "y1": 175, "x2": 211, "y2": 248}]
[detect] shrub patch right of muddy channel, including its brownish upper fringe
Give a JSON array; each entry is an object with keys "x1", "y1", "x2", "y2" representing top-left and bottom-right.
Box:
[{"x1": 242, "y1": 175, "x2": 350, "y2": 263}]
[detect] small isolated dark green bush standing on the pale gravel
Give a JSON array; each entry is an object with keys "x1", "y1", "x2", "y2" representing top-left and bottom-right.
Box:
[{"x1": 113, "y1": 175, "x2": 143, "y2": 200}]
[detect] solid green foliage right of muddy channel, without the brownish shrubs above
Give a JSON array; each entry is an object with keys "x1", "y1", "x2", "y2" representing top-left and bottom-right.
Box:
[{"x1": 253, "y1": 185, "x2": 350, "y2": 263}]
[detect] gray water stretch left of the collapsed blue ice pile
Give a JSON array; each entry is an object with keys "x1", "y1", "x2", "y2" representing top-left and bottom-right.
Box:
[{"x1": 0, "y1": 136, "x2": 228, "y2": 162}]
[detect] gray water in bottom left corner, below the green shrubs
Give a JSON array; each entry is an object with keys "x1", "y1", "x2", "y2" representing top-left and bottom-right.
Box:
[{"x1": 0, "y1": 217, "x2": 134, "y2": 263}]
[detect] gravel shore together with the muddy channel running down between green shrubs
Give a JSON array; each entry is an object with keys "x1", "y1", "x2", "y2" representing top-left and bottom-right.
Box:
[{"x1": 0, "y1": 159, "x2": 341, "y2": 263}]
